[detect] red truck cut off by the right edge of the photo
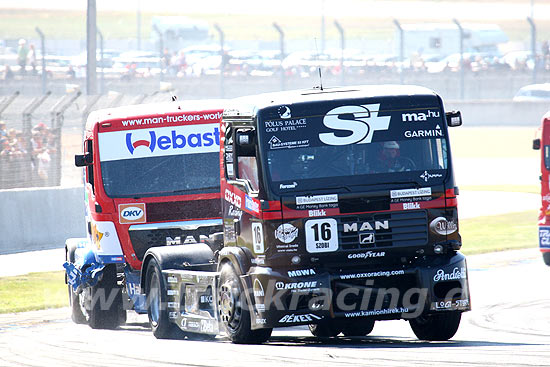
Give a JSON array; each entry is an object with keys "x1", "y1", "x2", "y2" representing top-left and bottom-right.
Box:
[{"x1": 533, "y1": 112, "x2": 550, "y2": 266}]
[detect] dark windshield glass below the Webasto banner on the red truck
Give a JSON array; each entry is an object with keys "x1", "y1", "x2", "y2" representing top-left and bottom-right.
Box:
[{"x1": 101, "y1": 153, "x2": 220, "y2": 198}]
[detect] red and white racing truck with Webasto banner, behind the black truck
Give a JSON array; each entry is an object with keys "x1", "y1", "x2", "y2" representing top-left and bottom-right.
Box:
[{"x1": 64, "y1": 101, "x2": 226, "y2": 328}]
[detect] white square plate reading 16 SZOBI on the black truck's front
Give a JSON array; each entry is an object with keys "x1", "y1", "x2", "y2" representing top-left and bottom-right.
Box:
[{"x1": 305, "y1": 218, "x2": 338, "y2": 253}]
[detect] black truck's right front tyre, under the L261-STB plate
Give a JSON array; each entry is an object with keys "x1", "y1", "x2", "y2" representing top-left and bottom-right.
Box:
[{"x1": 409, "y1": 311, "x2": 461, "y2": 341}]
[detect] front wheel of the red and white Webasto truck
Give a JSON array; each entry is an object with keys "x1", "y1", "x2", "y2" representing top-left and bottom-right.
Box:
[{"x1": 86, "y1": 264, "x2": 122, "y2": 329}]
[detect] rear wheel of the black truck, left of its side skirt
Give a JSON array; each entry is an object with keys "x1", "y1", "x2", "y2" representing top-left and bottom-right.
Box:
[{"x1": 145, "y1": 259, "x2": 184, "y2": 339}]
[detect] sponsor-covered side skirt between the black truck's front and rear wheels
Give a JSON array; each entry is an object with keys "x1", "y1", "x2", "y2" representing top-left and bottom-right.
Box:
[{"x1": 162, "y1": 270, "x2": 220, "y2": 335}]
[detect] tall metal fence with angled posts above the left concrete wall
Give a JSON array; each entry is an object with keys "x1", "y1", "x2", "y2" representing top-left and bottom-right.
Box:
[{"x1": 0, "y1": 91, "x2": 177, "y2": 189}]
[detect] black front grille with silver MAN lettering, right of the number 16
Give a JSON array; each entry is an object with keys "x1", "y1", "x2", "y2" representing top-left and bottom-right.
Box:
[{"x1": 337, "y1": 210, "x2": 428, "y2": 250}]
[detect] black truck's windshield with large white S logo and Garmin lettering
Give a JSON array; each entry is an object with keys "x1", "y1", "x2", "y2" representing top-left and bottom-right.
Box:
[{"x1": 259, "y1": 98, "x2": 448, "y2": 194}]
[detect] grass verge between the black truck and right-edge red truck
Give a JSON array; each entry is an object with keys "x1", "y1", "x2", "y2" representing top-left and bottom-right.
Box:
[{"x1": 460, "y1": 210, "x2": 538, "y2": 255}]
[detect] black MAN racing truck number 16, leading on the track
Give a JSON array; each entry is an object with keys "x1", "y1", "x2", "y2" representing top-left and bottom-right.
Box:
[{"x1": 154, "y1": 86, "x2": 470, "y2": 343}]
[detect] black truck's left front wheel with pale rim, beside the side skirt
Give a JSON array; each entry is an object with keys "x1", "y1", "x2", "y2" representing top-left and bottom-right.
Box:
[{"x1": 218, "y1": 264, "x2": 273, "y2": 344}]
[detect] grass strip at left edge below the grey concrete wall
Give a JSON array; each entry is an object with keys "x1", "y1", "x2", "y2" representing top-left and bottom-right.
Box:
[{"x1": 0, "y1": 271, "x2": 69, "y2": 313}]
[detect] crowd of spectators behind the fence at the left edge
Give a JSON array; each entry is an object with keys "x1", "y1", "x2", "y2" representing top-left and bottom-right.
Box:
[{"x1": 0, "y1": 121, "x2": 56, "y2": 189}]
